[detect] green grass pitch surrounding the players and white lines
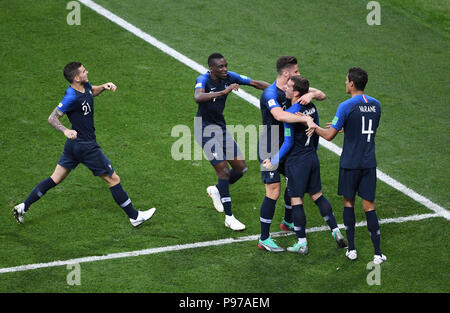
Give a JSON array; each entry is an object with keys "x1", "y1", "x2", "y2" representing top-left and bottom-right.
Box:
[{"x1": 0, "y1": 0, "x2": 450, "y2": 293}]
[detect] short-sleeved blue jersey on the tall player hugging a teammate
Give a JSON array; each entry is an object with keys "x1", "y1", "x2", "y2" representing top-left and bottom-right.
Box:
[{"x1": 258, "y1": 82, "x2": 290, "y2": 161}]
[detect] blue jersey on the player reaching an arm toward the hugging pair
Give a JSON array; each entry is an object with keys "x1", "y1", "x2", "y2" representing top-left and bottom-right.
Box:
[{"x1": 195, "y1": 71, "x2": 251, "y2": 128}]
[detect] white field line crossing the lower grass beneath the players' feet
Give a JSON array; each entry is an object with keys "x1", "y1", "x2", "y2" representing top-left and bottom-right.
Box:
[{"x1": 0, "y1": 213, "x2": 441, "y2": 274}]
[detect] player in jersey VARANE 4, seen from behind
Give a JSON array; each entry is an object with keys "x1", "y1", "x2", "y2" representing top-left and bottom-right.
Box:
[{"x1": 315, "y1": 67, "x2": 387, "y2": 264}]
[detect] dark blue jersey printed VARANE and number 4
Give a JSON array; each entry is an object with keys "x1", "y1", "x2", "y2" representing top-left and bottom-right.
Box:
[{"x1": 331, "y1": 94, "x2": 381, "y2": 169}]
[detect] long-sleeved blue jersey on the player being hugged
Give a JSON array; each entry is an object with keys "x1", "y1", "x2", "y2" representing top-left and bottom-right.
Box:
[{"x1": 271, "y1": 102, "x2": 319, "y2": 165}]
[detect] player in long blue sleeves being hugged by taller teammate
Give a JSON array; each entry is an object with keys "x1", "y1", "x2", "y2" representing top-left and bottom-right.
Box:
[{"x1": 263, "y1": 76, "x2": 346, "y2": 255}]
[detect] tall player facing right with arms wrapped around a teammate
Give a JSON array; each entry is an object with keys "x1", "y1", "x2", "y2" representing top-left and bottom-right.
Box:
[{"x1": 258, "y1": 56, "x2": 326, "y2": 252}]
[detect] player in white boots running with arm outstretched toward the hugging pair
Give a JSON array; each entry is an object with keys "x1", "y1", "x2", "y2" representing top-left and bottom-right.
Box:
[{"x1": 194, "y1": 53, "x2": 269, "y2": 231}]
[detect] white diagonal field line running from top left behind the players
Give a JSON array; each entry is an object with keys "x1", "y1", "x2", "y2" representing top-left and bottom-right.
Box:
[{"x1": 79, "y1": 0, "x2": 450, "y2": 220}]
